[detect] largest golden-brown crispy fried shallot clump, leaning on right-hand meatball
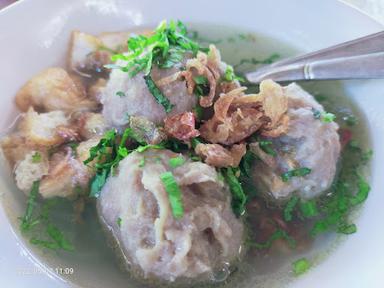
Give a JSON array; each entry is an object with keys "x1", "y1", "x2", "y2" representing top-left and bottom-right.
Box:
[{"x1": 200, "y1": 80, "x2": 289, "y2": 145}]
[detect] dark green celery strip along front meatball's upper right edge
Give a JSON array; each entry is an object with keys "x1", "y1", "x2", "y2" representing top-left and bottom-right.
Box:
[{"x1": 221, "y1": 168, "x2": 247, "y2": 216}]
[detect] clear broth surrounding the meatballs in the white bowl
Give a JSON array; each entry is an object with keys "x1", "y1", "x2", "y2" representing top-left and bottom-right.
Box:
[{"x1": 3, "y1": 25, "x2": 369, "y2": 288}]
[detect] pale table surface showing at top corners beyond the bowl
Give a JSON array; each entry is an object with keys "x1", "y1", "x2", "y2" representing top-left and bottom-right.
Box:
[{"x1": 0, "y1": 0, "x2": 384, "y2": 25}]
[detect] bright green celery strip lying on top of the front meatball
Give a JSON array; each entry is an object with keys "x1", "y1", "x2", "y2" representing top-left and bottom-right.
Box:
[{"x1": 160, "y1": 172, "x2": 184, "y2": 218}]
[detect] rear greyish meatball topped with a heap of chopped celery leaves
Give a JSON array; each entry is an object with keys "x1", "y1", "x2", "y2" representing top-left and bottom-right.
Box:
[{"x1": 101, "y1": 59, "x2": 196, "y2": 127}]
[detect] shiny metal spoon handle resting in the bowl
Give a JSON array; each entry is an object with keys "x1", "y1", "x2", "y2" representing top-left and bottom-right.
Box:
[{"x1": 245, "y1": 31, "x2": 384, "y2": 83}]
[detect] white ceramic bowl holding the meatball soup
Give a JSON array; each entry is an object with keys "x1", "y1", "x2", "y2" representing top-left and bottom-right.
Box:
[{"x1": 0, "y1": 0, "x2": 384, "y2": 288}]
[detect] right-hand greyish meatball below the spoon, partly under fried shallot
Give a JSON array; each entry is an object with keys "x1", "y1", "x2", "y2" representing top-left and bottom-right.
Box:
[{"x1": 250, "y1": 84, "x2": 340, "y2": 199}]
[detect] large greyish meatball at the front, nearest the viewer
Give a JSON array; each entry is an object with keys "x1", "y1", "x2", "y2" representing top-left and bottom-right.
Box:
[{"x1": 98, "y1": 150, "x2": 244, "y2": 281}]
